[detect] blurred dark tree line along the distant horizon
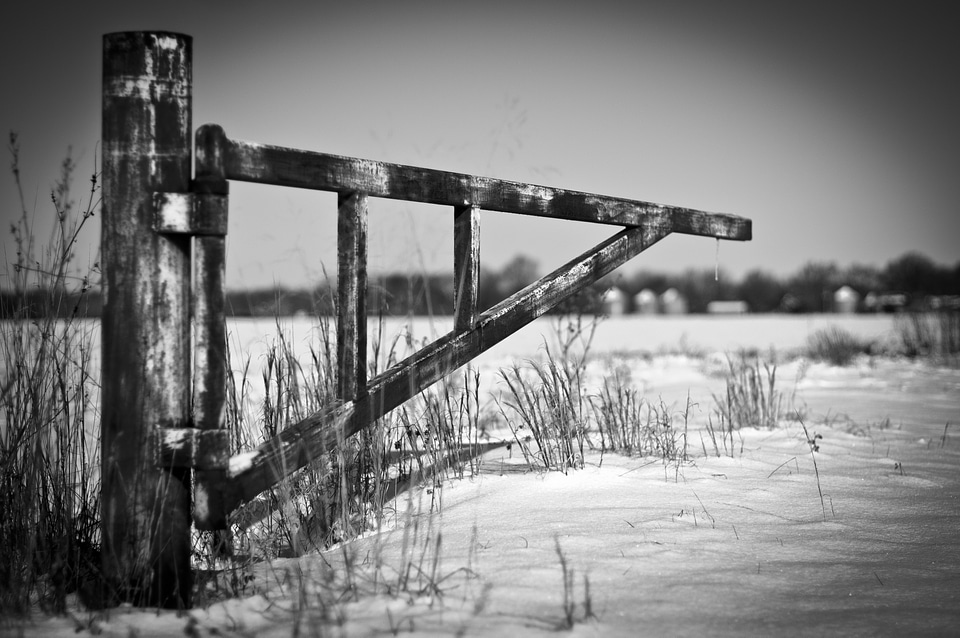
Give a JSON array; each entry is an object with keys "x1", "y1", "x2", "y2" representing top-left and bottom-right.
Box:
[{"x1": 0, "y1": 253, "x2": 960, "y2": 318}]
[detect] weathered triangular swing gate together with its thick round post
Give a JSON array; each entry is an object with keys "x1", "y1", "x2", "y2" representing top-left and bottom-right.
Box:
[{"x1": 101, "y1": 32, "x2": 751, "y2": 607}]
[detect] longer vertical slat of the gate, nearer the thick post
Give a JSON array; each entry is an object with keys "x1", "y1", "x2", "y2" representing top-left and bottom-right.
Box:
[{"x1": 337, "y1": 193, "x2": 367, "y2": 401}]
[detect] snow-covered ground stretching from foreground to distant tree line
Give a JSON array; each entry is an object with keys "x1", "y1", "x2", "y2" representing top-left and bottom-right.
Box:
[{"x1": 15, "y1": 316, "x2": 960, "y2": 636}]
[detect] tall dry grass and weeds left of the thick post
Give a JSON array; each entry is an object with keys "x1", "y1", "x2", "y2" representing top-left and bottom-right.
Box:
[{"x1": 0, "y1": 134, "x2": 100, "y2": 615}]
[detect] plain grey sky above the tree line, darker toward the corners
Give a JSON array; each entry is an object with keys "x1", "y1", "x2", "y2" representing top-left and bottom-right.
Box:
[{"x1": 0, "y1": 0, "x2": 960, "y2": 288}]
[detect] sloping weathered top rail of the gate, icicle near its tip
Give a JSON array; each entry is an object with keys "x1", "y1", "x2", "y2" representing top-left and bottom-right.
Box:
[{"x1": 197, "y1": 124, "x2": 752, "y2": 241}]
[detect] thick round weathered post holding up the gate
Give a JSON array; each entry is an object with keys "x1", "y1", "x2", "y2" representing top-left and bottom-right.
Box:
[{"x1": 101, "y1": 32, "x2": 192, "y2": 608}]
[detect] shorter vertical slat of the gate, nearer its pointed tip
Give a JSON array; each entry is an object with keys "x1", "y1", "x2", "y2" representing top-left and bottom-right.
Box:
[{"x1": 453, "y1": 206, "x2": 480, "y2": 333}]
